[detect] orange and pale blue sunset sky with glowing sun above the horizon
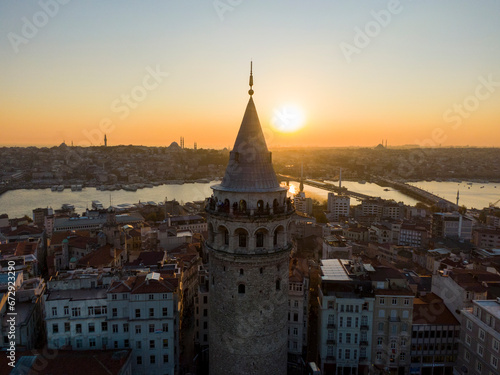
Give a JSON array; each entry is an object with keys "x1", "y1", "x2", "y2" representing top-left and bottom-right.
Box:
[{"x1": 0, "y1": 0, "x2": 500, "y2": 148}]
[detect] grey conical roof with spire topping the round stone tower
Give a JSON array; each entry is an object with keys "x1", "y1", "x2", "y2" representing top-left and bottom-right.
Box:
[{"x1": 214, "y1": 64, "x2": 283, "y2": 192}]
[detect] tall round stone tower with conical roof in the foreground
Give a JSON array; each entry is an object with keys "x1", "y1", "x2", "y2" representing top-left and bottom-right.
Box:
[{"x1": 205, "y1": 63, "x2": 294, "y2": 375}]
